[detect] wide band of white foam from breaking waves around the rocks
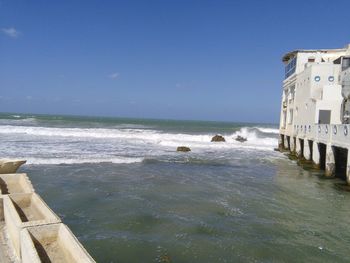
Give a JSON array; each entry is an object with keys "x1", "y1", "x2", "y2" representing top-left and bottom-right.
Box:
[{"x1": 0, "y1": 125, "x2": 277, "y2": 164}]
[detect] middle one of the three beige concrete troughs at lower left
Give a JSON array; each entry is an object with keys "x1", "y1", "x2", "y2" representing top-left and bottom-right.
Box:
[{"x1": 3, "y1": 193, "x2": 61, "y2": 257}]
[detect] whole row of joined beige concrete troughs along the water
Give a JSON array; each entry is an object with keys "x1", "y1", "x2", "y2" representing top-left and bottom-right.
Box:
[{"x1": 0, "y1": 160, "x2": 95, "y2": 263}]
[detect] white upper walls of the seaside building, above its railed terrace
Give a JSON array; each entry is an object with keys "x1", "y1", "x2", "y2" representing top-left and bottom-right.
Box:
[{"x1": 280, "y1": 48, "x2": 349, "y2": 136}]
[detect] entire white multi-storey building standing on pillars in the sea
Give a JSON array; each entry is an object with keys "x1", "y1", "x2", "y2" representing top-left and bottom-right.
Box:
[{"x1": 279, "y1": 45, "x2": 350, "y2": 184}]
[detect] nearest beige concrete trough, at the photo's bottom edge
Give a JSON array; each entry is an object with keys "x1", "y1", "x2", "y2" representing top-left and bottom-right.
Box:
[{"x1": 20, "y1": 223, "x2": 95, "y2": 263}]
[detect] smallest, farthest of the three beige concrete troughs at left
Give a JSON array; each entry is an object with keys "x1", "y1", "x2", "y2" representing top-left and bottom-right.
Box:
[{"x1": 0, "y1": 173, "x2": 34, "y2": 195}]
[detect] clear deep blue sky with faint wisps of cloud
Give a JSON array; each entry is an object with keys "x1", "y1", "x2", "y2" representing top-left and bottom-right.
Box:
[{"x1": 0, "y1": 0, "x2": 350, "y2": 122}]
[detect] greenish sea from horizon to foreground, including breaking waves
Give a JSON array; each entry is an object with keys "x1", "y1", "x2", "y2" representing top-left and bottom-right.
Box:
[{"x1": 0, "y1": 114, "x2": 350, "y2": 263}]
